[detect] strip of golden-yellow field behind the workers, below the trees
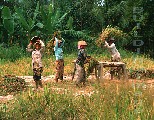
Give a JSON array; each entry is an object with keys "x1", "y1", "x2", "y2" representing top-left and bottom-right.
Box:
[{"x1": 0, "y1": 47, "x2": 154, "y2": 76}]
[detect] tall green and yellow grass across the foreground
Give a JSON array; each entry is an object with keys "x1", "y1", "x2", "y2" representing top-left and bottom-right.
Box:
[{"x1": 1, "y1": 83, "x2": 154, "y2": 120}]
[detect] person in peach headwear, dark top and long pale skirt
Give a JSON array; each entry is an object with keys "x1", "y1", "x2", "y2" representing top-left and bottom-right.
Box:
[{"x1": 75, "y1": 41, "x2": 87, "y2": 87}]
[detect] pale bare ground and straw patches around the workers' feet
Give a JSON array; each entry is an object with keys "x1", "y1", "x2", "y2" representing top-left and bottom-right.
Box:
[{"x1": 0, "y1": 75, "x2": 154, "y2": 103}]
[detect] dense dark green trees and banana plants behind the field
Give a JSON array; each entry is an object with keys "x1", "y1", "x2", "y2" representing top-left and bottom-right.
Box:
[{"x1": 0, "y1": 0, "x2": 154, "y2": 57}]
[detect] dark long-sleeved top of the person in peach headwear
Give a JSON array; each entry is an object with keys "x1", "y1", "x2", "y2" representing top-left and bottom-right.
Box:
[{"x1": 76, "y1": 49, "x2": 87, "y2": 67}]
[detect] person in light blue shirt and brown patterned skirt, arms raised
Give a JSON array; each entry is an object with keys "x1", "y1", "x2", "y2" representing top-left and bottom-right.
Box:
[{"x1": 54, "y1": 36, "x2": 65, "y2": 82}]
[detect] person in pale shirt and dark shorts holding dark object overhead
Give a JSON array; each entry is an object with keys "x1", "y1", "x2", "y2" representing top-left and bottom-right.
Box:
[{"x1": 27, "y1": 36, "x2": 45, "y2": 89}]
